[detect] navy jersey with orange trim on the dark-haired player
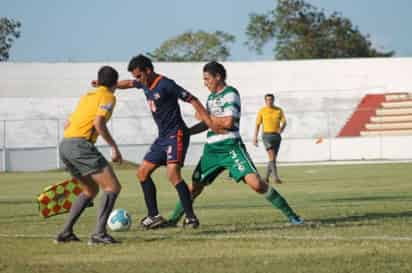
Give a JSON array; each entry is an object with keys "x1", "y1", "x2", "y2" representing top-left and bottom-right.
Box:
[{"x1": 134, "y1": 75, "x2": 194, "y2": 137}]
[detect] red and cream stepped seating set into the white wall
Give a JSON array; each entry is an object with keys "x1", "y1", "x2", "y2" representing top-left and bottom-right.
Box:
[{"x1": 338, "y1": 93, "x2": 412, "y2": 137}]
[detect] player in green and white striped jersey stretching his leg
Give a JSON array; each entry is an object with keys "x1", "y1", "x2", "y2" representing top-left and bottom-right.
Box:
[{"x1": 168, "y1": 62, "x2": 303, "y2": 226}]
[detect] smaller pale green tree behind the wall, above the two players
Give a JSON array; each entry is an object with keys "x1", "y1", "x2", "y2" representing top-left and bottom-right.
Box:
[{"x1": 148, "y1": 31, "x2": 235, "y2": 62}]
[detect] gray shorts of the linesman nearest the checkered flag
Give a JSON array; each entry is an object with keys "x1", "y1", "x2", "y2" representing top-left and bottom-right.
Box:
[{"x1": 59, "y1": 138, "x2": 109, "y2": 179}]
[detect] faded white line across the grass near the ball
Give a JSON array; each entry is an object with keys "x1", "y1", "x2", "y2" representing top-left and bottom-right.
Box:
[{"x1": 0, "y1": 234, "x2": 412, "y2": 241}]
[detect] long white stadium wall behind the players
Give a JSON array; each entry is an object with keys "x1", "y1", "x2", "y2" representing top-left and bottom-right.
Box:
[{"x1": 0, "y1": 58, "x2": 412, "y2": 171}]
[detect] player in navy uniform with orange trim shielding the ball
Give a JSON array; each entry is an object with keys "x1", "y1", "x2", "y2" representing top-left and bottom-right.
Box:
[{"x1": 117, "y1": 55, "x2": 219, "y2": 228}]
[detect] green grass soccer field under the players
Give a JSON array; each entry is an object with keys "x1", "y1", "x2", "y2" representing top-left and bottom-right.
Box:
[{"x1": 0, "y1": 163, "x2": 412, "y2": 273}]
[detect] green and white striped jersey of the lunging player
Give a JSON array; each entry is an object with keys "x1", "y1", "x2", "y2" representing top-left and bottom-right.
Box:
[{"x1": 206, "y1": 86, "x2": 241, "y2": 143}]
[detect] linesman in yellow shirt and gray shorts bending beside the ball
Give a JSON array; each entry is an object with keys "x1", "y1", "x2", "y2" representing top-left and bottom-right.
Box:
[{"x1": 55, "y1": 66, "x2": 122, "y2": 244}]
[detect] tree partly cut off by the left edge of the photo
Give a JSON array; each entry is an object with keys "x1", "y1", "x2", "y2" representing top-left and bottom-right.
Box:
[{"x1": 0, "y1": 17, "x2": 21, "y2": 62}]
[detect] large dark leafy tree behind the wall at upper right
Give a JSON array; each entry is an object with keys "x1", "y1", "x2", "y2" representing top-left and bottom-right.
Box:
[{"x1": 246, "y1": 0, "x2": 395, "y2": 60}]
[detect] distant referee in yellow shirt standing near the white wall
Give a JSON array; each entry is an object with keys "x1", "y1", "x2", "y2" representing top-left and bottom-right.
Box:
[{"x1": 253, "y1": 94, "x2": 286, "y2": 184}]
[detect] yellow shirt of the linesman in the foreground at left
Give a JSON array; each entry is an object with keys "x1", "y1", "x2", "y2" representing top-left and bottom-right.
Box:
[{"x1": 64, "y1": 86, "x2": 116, "y2": 143}]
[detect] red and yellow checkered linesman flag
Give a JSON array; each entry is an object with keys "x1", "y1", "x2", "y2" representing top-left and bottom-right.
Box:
[{"x1": 37, "y1": 178, "x2": 82, "y2": 218}]
